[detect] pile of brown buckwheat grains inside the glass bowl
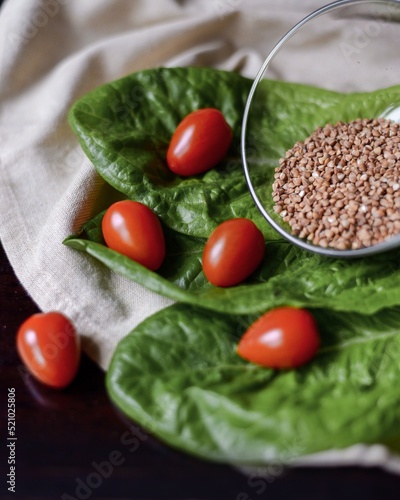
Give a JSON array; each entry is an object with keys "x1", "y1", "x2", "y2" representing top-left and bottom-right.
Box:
[{"x1": 272, "y1": 118, "x2": 400, "y2": 250}]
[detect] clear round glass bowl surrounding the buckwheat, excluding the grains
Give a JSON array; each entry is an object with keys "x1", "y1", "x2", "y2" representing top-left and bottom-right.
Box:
[{"x1": 241, "y1": 0, "x2": 400, "y2": 257}]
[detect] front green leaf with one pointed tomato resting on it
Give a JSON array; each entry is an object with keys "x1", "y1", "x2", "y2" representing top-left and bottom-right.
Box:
[{"x1": 107, "y1": 304, "x2": 400, "y2": 465}]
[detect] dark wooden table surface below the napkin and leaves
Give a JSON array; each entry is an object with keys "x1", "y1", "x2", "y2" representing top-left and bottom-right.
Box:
[{"x1": 0, "y1": 243, "x2": 400, "y2": 500}]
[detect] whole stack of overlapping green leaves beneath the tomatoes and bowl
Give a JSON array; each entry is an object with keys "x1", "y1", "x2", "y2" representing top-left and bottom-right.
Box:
[{"x1": 65, "y1": 68, "x2": 400, "y2": 465}]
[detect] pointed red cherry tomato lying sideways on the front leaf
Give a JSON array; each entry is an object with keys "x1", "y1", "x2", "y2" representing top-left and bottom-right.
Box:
[{"x1": 237, "y1": 307, "x2": 320, "y2": 368}]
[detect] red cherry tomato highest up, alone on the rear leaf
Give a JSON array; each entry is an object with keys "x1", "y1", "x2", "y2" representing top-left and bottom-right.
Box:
[{"x1": 167, "y1": 108, "x2": 232, "y2": 176}]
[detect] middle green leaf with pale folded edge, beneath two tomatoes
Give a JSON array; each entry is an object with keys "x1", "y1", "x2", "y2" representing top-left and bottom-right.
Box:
[{"x1": 65, "y1": 214, "x2": 400, "y2": 314}]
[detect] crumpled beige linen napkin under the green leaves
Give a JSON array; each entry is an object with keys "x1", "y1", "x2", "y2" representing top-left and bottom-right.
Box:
[{"x1": 0, "y1": 0, "x2": 400, "y2": 471}]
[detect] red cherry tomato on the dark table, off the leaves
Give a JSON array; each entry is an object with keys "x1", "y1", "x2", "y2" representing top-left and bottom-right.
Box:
[{"x1": 17, "y1": 312, "x2": 80, "y2": 389}]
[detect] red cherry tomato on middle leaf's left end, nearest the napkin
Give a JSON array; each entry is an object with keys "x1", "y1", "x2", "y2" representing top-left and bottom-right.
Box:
[{"x1": 102, "y1": 200, "x2": 165, "y2": 271}]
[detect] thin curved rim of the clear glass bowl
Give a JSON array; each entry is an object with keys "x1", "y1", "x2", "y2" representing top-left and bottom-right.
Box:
[{"x1": 241, "y1": 0, "x2": 400, "y2": 258}]
